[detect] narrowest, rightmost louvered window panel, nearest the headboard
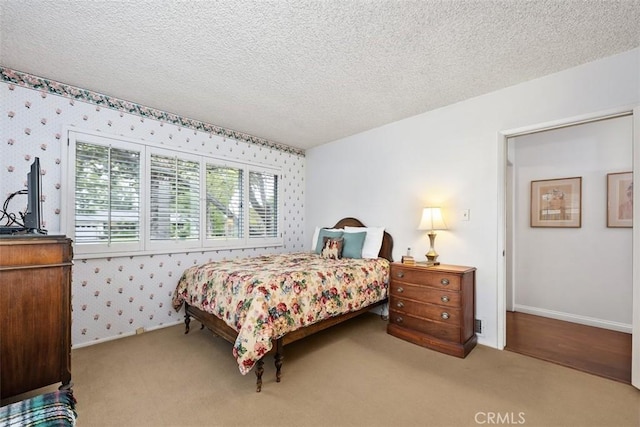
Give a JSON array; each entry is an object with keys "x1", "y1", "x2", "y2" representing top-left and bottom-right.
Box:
[{"x1": 249, "y1": 171, "x2": 278, "y2": 239}]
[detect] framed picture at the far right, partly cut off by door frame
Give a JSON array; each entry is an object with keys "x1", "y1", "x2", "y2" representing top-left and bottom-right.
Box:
[{"x1": 607, "y1": 172, "x2": 633, "y2": 227}]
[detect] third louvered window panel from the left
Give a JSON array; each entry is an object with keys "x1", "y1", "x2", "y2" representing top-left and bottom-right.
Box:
[{"x1": 206, "y1": 164, "x2": 244, "y2": 240}]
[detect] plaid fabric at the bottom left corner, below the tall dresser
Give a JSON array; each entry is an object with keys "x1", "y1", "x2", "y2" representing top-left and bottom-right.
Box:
[{"x1": 0, "y1": 390, "x2": 77, "y2": 427}]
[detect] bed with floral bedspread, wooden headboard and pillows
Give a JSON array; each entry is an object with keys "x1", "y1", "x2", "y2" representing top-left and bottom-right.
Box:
[{"x1": 172, "y1": 218, "x2": 393, "y2": 392}]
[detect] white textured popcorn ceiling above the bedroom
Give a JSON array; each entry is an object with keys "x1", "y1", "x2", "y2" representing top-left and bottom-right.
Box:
[{"x1": 0, "y1": 0, "x2": 640, "y2": 149}]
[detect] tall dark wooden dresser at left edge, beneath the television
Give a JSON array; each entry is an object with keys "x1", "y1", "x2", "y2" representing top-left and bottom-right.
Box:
[{"x1": 0, "y1": 235, "x2": 73, "y2": 399}]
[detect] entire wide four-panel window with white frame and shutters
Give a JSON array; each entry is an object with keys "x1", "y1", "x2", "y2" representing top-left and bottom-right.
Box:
[{"x1": 67, "y1": 130, "x2": 282, "y2": 254}]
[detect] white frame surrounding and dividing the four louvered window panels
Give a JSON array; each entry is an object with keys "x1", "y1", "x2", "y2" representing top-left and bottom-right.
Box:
[{"x1": 61, "y1": 127, "x2": 284, "y2": 257}]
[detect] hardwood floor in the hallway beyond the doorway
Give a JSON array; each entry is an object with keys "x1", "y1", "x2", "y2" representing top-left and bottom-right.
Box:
[{"x1": 505, "y1": 311, "x2": 631, "y2": 384}]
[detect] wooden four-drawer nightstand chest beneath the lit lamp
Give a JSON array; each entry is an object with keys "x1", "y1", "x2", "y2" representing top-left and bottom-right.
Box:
[{"x1": 387, "y1": 263, "x2": 478, "y2": 357}]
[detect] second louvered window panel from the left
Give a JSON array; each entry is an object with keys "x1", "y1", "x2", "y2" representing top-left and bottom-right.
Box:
[{"x1": 149, "y1": 154, "x2": 200, "y2": 240}]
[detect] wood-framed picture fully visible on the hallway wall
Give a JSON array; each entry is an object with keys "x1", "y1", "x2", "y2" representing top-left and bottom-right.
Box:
[{"x1": 531, "y1": 177, "x2": 582, "y2": 228}]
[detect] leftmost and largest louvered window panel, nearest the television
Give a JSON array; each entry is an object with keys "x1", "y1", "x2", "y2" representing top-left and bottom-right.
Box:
[{"x1": 75, "y1": 142, "x2": 140, "y2": 245}]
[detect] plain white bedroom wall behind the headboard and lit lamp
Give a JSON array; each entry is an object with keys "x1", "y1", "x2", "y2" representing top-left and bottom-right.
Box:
[{"x1": 305, "y1": 49, "x2": 640, "y2": 347}]
